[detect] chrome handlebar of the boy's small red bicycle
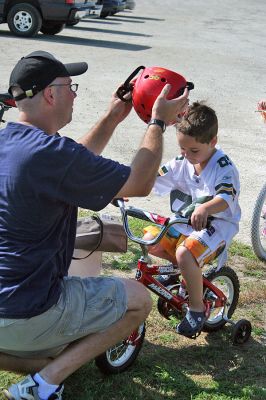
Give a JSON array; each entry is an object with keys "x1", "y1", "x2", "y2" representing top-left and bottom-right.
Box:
[{"x1": 113, "y1": 199, "x2": 211, "y2": 246}]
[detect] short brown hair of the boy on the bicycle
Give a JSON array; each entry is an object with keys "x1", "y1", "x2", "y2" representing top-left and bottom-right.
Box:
[{"x1": 177, "y1": 101, "x2": 218, "y2": 143}]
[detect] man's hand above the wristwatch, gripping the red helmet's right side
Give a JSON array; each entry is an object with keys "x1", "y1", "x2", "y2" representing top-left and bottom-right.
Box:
[{"x1": 152, "y1": 84, "x2": 189, "y2": 125}]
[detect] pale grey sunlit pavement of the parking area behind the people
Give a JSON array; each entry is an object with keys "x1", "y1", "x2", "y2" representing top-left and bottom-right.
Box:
[{"x1": 0, "y1": 0, "x2": 266, "y2": 244}]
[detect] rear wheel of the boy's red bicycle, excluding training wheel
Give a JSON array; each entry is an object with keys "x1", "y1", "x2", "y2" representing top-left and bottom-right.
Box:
[{"x1": 203, "y1": 267, "x2": 240, "y2": 332}]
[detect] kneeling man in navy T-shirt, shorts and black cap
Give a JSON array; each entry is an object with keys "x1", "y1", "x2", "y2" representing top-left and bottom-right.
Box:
[{"x1": 0, "y1": 51, "x2": 188, "y2": 400}]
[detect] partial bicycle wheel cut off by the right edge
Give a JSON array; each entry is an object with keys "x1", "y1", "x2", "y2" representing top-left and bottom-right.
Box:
[{"x1": 251, "y1": 183, "x2": 266, "y2": 260}]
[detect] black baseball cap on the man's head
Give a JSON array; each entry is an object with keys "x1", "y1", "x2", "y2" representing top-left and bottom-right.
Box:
[{"x1": 8, "y1": 51, "x2": 88, "y2": 100}]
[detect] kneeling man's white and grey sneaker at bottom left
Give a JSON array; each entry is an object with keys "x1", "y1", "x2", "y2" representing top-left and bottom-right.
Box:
[{"x1": 3, "y1": 375, "x2": 64, "y2": 400}]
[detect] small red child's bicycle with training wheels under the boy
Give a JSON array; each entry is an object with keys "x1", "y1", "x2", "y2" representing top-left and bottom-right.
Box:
[{"x1": 95, "y1": 200, "x2": 251, "y2": 374}]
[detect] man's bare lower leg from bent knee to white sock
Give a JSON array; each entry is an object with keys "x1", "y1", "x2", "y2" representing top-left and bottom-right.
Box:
[{"x1": 32, "y1": 280, "x2": 152, "y2": 385}]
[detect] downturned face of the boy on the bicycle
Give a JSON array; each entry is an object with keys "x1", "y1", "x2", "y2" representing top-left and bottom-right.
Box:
[{"x1": 177, "y1": 132, "x2": 217, "y2": 165}]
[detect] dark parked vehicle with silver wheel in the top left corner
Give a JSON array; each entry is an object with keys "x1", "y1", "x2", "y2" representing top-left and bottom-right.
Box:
[{"x1": 0, "y1": 0, "x2": 102, "y2": 37}]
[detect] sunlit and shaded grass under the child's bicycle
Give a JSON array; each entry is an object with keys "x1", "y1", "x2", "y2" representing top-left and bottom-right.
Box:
[{"x1": 0, "y1": 219, "x2": 266, "y2": 400}]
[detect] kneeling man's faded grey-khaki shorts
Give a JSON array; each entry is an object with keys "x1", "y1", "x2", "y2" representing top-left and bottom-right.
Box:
[{"x1": 0, "y1": 277, "x2": 127, "y2": 358}]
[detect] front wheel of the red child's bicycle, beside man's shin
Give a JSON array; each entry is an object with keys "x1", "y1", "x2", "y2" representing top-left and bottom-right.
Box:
[{"x1": 95, "y1": 323, "x2": 145, "y2": 374}]
